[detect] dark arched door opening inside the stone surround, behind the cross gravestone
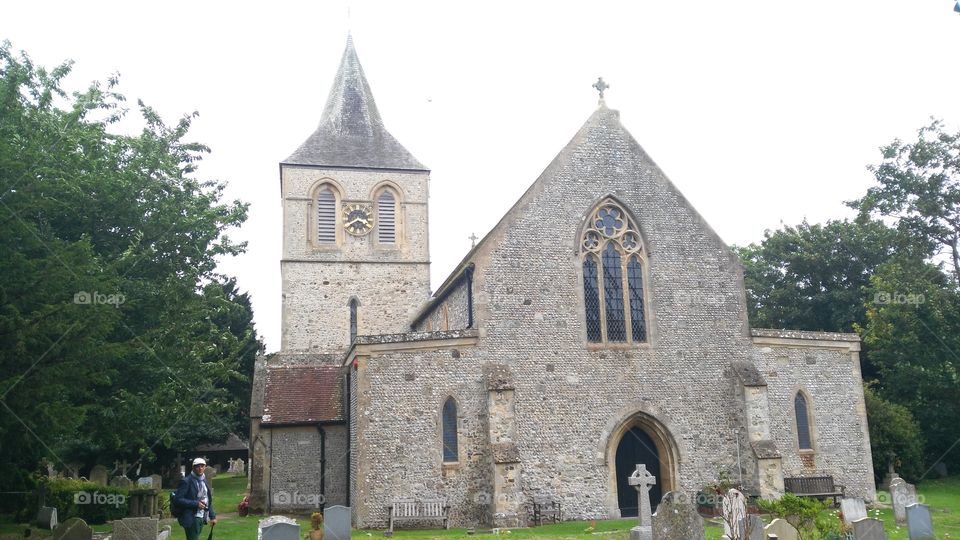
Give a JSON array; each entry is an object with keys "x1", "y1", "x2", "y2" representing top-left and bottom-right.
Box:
[{"x1": 616, "y1": 426, "x2": 663, "y2": 517}]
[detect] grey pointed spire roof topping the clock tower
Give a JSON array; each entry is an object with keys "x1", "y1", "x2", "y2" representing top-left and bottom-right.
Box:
[{"x1": 284, "y1": 34, "x2": 426, "y2": 170}]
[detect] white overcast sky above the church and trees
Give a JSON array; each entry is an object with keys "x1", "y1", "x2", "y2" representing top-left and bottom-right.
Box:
[{"x1": 0, "y1": 0, "x2": 960, "y2": 351}]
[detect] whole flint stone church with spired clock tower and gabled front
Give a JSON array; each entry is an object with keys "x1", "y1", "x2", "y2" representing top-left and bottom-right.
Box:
[{"x1": 250, "y1": 38, "x2": 875, "y2": 527}]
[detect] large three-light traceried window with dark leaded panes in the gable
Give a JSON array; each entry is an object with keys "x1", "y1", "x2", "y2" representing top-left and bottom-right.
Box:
[{"x1": 580, "y1": 199, "x2": 647, "y2": 343}]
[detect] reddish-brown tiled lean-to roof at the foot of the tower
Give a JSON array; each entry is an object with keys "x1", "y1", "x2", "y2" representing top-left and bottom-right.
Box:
[{"x1": 262, "y1": 365, "x2": 343, "y2": 424}]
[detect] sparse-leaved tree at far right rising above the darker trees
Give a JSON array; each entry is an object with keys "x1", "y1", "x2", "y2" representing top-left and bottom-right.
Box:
[{"x1": 848, "y1": 120, "x2": 960, "y2": 285}]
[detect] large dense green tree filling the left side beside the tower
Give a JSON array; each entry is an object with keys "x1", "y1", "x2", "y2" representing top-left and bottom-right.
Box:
[{"x1": 0, "y1": 43, "x2": 260, "y2": 506}]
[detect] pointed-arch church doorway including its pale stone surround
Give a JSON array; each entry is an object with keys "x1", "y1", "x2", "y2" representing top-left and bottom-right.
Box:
[{"x1": 606, "y1": 412, "x2": 680, "y2": 517}]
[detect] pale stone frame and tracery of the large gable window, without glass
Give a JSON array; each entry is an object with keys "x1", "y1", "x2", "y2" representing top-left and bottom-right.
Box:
[{"x1": 577, "y1": 195, "x2": 653, "y2": 350}]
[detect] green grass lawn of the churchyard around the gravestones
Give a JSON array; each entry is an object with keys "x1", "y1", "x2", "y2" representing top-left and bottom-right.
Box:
[{"x1": 0, "y1": 474, "x2": 960, "y2": 540}]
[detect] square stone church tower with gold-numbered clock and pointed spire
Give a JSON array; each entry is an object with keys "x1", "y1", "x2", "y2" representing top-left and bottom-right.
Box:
[{"x1": 280, "y1": 37, "x2": 430, "y2": 353}]
